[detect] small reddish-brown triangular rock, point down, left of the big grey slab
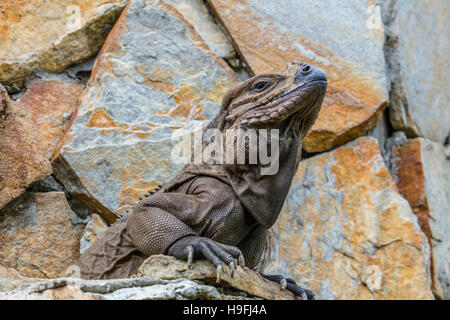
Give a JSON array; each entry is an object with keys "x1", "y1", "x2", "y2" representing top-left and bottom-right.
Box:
[{"x1": 17, "y1": 80, "x2": 83, "y2": 159}]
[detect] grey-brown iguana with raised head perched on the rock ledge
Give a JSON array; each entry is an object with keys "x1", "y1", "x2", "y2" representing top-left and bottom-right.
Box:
[{"x1": 78, "y1": 62, "x2": 327, "y2": 298}]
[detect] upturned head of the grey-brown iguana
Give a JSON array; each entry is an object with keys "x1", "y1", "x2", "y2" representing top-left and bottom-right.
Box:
[{"x1": 214, "y1": 62, "x2": 327, "y2": 138}]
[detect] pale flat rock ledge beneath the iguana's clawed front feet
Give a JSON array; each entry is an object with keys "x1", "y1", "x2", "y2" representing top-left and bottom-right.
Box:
[{"x1": 0, "y1": 255, "x2": 294, "y2": 300}]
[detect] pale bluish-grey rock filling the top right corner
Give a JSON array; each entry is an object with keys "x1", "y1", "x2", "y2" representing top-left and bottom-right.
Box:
[{"x1": 382, "y1": 0, "x2": 450, "y2": 143}]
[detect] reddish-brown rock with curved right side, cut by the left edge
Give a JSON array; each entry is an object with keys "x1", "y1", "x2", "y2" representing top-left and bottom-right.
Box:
[{"x1": 0, "y1": 85, "x2": 52, "y2": 209}]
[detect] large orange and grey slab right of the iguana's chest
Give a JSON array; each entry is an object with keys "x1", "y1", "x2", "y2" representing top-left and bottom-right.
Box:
[{"x1": 264, "y1": 137, "x2": 433, "y2": 299}]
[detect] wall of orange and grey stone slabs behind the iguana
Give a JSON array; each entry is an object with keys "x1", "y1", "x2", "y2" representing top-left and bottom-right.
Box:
[{"x1": 0, "y1": 0, "x2": 450, "y2": 299}]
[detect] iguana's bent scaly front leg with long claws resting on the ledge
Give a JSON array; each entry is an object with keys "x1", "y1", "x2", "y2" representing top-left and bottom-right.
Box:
[{"x1": 127, "y1": 193, "x2": 243, "y2": 277}]
